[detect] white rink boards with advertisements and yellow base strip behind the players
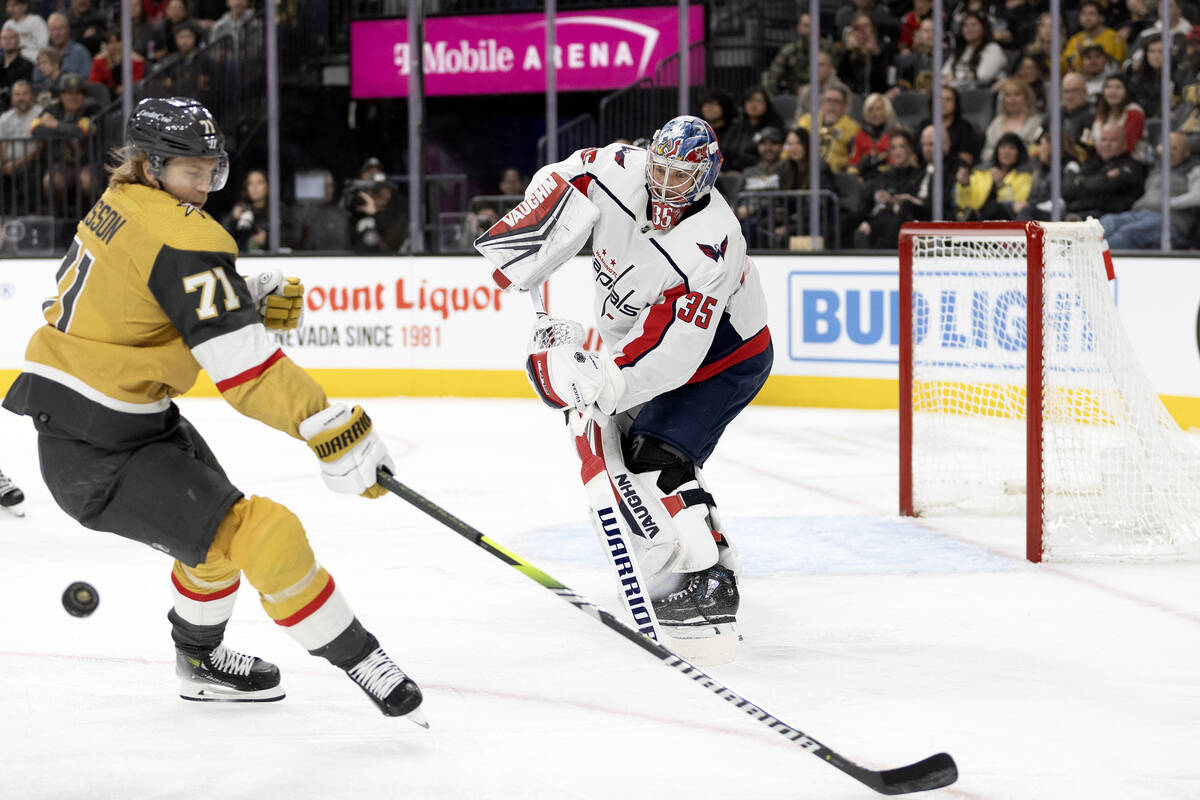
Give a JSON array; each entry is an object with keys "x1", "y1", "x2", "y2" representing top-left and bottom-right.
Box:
[{"x1": 0, "y1": 254, "x2": 1200, "y2": 427}]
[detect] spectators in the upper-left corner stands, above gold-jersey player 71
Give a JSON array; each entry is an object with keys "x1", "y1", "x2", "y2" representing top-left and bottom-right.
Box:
[{"x1": 0, "y1": 0, "x2": 260, "y2": 247}]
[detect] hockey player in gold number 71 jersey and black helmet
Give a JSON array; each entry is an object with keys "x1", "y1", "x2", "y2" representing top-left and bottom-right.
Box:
[{"x1": 4, "y1": 97, "x2": 421, "y2": 722}]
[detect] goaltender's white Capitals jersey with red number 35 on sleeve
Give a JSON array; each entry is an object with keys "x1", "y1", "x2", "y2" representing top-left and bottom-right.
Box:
[{"x1": 529, "y1": 144, "x2": 770, "y2": 413}]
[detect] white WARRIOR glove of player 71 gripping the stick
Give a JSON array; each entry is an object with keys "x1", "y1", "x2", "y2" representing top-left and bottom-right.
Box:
[{"x1": 300, "y1": 403, "x2": 394, "y2": 498}]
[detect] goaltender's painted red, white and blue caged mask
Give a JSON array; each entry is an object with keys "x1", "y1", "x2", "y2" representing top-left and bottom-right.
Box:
[{"x1": 646, "y1": 115, "x2": 721, "y2": 230}]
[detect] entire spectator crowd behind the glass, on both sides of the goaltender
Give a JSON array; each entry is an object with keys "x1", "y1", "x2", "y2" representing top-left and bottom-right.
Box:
[{"x1": 7, "y1": 0, "x2": 1200, "y2": 253}]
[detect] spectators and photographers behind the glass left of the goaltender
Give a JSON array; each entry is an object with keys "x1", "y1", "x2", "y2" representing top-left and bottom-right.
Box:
[{"x1": 0, "y1": 0, "x2": 432, "y2": 253}]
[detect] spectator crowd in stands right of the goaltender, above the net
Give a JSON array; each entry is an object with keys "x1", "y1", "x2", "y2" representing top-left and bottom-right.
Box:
[{"x1": 696, "y1": 0, "x2": 1200, "y2": 248}]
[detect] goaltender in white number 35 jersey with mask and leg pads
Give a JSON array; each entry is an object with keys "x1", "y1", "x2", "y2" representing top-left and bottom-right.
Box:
[{"x1": 476, "y1": 116, "x2": 773, "y2": 663}]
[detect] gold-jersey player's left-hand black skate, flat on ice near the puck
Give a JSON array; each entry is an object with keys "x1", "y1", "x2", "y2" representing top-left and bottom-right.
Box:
[{"x1": 175, "y1": 644, "x2": 283, "y2": 703}]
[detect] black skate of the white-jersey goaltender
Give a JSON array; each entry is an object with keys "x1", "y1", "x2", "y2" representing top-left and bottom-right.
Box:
[{"x1": 654, "y1": 564, "x2": 740, "y2": 667}]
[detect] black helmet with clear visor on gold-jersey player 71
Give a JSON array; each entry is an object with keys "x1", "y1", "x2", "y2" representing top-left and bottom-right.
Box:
[{"x1": 125, "y1": 97, "x2": 229, "y2": 192}]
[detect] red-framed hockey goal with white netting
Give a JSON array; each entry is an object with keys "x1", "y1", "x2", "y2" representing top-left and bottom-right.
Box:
[{"x1": 900, "y1": 221, "x2": 1200, "y2": 561}]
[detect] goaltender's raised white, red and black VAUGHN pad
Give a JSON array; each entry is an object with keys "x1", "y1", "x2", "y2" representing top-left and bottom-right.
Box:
[{"x1": 475, "y1": 173, "x2": 600, "y2": 291}]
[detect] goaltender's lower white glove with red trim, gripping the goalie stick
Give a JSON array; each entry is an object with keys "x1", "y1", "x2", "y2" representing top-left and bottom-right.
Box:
[{"x1": 526, "y1": 347, "x2": 625, "y2": 415}]
